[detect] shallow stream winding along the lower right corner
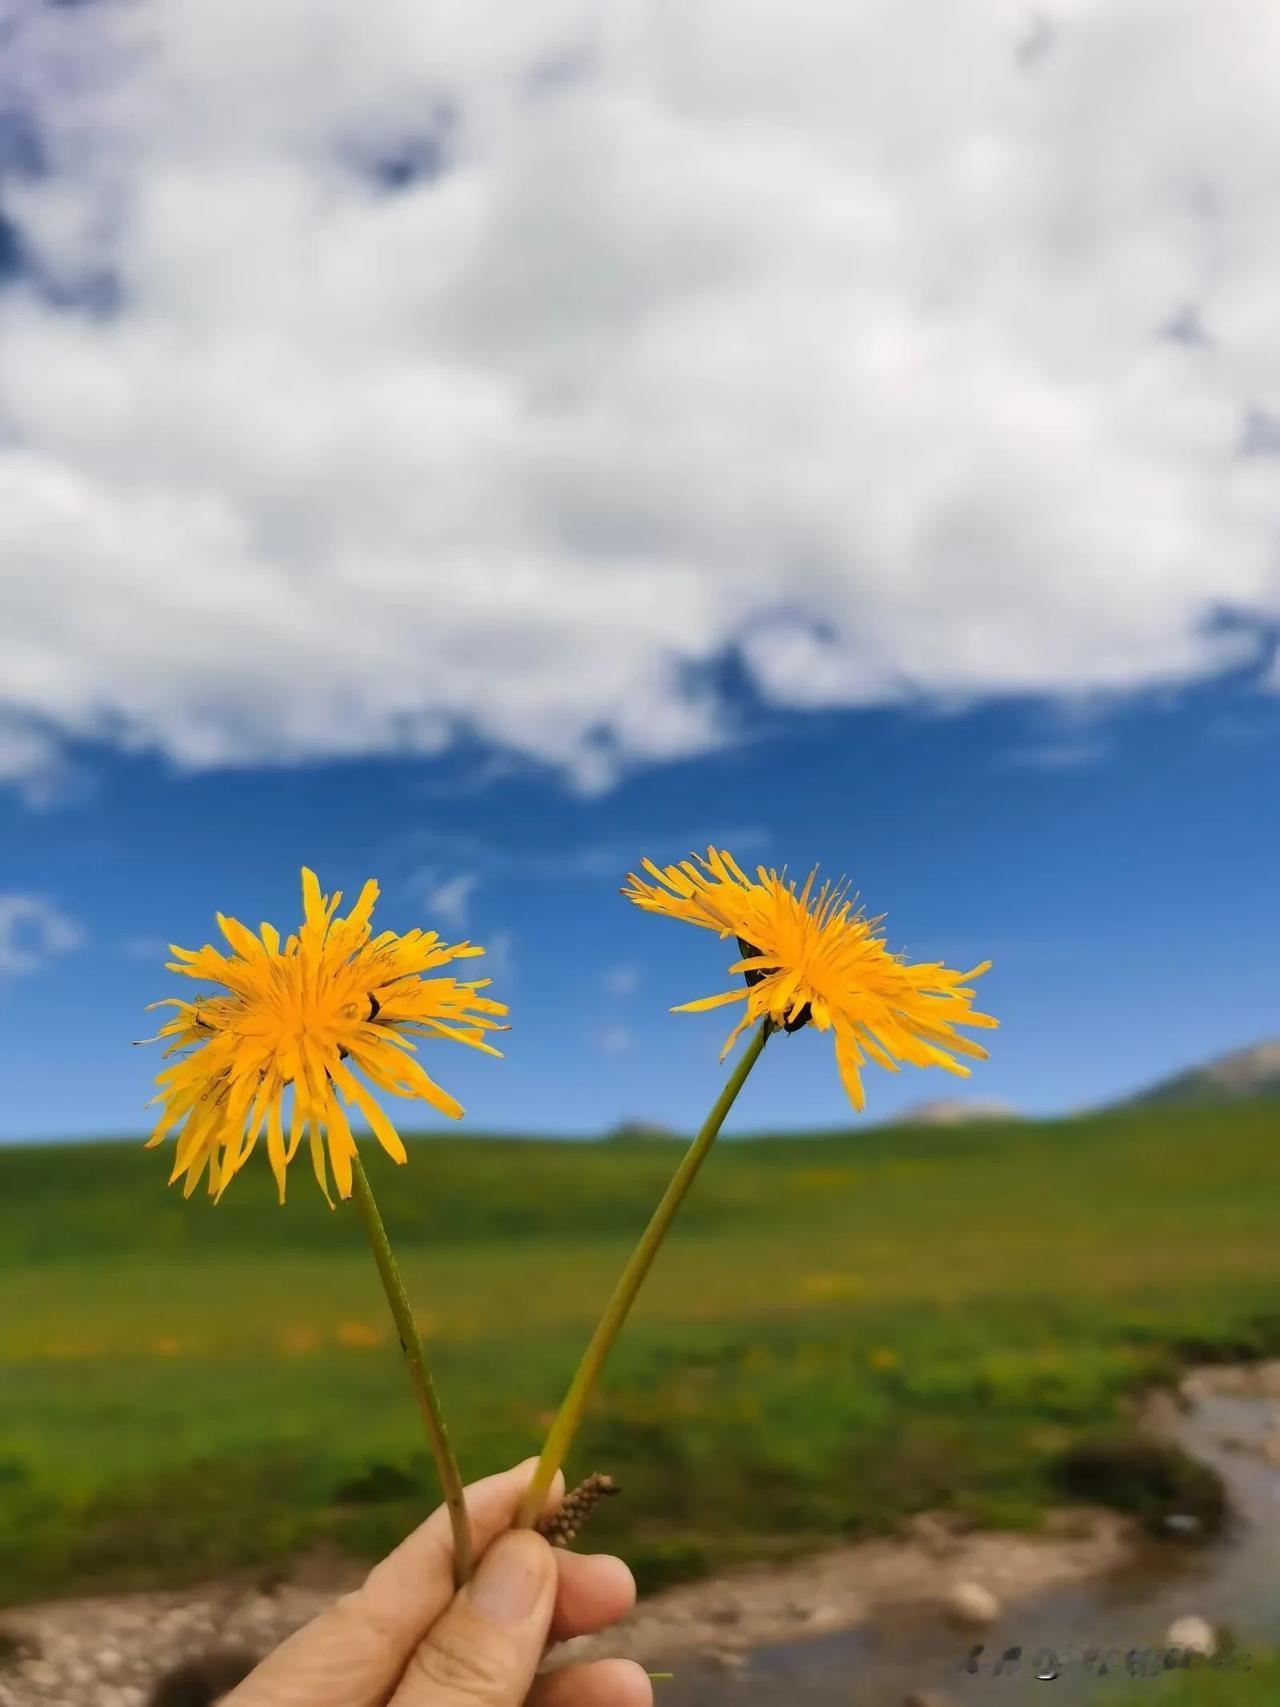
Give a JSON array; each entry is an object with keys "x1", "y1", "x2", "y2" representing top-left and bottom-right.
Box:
[{"x1": 657, "y1": 1393, "x2": 1280, "y2": 1707}]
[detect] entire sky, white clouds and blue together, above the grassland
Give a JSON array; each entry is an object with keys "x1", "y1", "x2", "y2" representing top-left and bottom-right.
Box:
[{"x1": 0, "y1": 0, "x2": 1280, "y2": 1135}]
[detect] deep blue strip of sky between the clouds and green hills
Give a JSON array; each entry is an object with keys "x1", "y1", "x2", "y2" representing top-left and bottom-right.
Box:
[{"x1": 0, "y1": 678, "x2": 1280, "y2": 1137}]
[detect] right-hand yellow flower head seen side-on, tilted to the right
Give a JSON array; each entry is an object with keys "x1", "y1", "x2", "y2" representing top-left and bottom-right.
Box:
[{"x1": 623, "y1": 848, "x2": 998, "y2": 1110}]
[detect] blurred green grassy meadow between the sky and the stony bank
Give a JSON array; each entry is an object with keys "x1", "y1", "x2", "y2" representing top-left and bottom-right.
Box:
[{"x1": 0, "y1": 1104, "x2": 1280, "y2": 1603}]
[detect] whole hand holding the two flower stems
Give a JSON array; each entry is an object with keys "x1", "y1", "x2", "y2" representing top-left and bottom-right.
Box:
[{"x1": 224, "y1": 1459, "x2": 654, "y2": 1707}]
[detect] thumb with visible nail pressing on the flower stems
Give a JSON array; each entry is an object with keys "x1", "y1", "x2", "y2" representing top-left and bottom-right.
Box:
[{"x1": 391, "y1": 1529, "x2": 556, "y2": 1707}]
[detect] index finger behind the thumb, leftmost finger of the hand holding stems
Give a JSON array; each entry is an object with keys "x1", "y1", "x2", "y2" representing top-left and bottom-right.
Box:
[{"x1": 225, "y1": 1458, "x2": 563, "y2": 1707}]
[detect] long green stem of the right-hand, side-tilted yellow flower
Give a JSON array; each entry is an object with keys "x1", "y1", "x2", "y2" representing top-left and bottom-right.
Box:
[{"x1": 515, "y1": 1019, "x2": 773, "y2": 1528}]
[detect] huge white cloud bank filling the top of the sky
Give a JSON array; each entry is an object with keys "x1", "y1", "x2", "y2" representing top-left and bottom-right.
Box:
[{"x1": 0, "y1": 0, "x2": 1280, "y2": 787}]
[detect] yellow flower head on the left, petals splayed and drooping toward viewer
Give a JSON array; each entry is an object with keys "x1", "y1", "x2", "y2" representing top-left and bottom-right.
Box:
[{"x1": 148, "y1": 869, "x2": 507, "y2": 1202}]
